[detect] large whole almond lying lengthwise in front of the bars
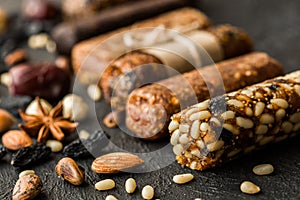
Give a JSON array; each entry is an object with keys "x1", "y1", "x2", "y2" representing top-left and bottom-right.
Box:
[{"x1": 92, "y1": 152, "x2": 144, "y2": 174}]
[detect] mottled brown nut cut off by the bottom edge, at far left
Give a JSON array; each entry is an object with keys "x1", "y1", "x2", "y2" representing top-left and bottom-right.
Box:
[{"x1": 12, "y1": 174, "x2": 43, "y2": 200}]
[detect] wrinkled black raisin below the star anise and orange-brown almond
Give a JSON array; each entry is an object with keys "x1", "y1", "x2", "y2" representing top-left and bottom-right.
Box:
[{"x1": 11, "y1": 143, "x2": 51, "y2": 167}]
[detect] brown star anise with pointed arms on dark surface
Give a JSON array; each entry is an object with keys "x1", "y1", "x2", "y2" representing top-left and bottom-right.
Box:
[{"x1": 19, "y1": 97, "x2": 78, "y2": 143}]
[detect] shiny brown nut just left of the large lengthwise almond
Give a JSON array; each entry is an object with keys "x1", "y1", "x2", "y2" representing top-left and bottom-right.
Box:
[{"x1": 55, "y1": 157, "x2": 84, "y2": 185}]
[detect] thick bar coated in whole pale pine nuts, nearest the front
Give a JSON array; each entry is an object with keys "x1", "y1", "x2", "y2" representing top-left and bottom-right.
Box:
[{"x1": 169, "y1": 71, "x2": 300, "y2": 170}]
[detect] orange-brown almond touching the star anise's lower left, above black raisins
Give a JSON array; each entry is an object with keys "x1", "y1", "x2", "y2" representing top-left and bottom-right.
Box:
[{"x1": 2, "y1": 130, "x2": 32, "y2": 151}]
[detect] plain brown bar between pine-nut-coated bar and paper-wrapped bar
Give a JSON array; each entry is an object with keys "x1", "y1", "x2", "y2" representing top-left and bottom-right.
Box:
[{"x1": 126, "y1": 52, "x2": 283, "y2": 140}]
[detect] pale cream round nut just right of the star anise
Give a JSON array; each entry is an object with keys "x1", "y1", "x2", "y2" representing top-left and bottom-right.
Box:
[{"x1": 62, "y1": 94, "x2": 88, "y2": 120}]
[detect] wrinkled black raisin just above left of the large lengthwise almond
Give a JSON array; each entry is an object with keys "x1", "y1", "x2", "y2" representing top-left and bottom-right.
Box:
[{"x1": 63, "y1": 130, "x2": 109, "y2": 158}]
